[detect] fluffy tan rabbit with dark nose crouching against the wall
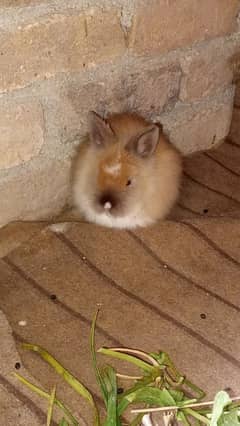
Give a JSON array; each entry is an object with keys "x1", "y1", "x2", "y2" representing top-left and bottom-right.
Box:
[{"x1": 73, "y1": 114, "x2": 182, "y2": 229}]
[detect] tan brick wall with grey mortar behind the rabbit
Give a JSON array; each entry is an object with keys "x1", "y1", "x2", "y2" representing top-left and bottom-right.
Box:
[{"x1": 0, "y1": 0, "x2": 240, "y2": 225}]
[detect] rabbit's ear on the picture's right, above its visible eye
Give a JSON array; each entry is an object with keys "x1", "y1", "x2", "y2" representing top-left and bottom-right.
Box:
[{"x1": 126, "y1": 124, "x2": 160, "y2": 158}]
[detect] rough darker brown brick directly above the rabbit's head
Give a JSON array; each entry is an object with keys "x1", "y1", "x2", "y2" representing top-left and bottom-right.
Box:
[{"x1": 62, "y1": 63, "x2": 181, "y2": 141}]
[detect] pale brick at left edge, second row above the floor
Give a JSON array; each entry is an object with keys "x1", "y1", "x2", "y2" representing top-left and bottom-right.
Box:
[{"x1": 0, "y1": 101, "x2": 44, "y2": 169}]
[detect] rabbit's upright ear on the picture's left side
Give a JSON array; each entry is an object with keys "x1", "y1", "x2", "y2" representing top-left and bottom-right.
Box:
[{"x1": 88, "y1": 111, "x2": 114, "y2": 147}]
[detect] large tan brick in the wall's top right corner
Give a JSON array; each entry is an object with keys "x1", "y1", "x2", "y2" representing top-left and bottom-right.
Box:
[{"x1": 130, "y1": 0, "x2": 239, "y2": 54}]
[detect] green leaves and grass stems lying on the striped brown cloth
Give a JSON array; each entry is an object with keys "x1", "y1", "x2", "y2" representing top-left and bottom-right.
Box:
[{"x1": 14, "y1": 312, "x2": 240, "y2": 426}]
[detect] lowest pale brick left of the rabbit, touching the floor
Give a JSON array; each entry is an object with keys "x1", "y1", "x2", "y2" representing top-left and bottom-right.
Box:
[{"x1": 0, "y1": 159, "x2": 70, "y2": 230}]
